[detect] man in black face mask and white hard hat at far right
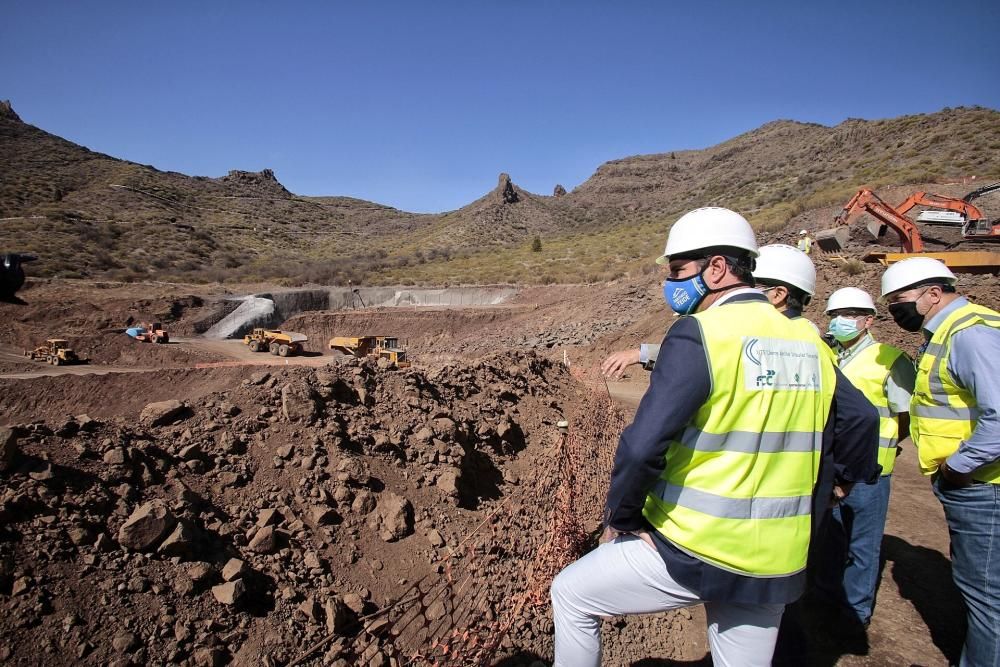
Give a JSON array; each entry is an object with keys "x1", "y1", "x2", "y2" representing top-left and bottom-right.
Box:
[{"x1": 882, "y1": 257, "x2": 1000, "y2": 665}]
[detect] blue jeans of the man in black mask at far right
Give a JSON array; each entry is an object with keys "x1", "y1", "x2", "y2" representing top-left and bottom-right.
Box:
[{"x1": 934, "y1": 475, "x2": 1000, "y2": 667}]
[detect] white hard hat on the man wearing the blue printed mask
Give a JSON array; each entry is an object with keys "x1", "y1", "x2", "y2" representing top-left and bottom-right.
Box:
[{"x1": 656, "y1": 206, "x2": 757, "y2": 264}]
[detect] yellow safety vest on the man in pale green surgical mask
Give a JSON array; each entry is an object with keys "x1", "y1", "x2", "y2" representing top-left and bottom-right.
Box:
[{"x1": 840, "y1": 342, "x2": 903, "y2": 475}]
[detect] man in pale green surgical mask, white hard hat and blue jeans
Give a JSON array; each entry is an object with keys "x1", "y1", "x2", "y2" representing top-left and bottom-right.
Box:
[{"x1": 816, "y1": 287, "x2": 916, "y2": 627}]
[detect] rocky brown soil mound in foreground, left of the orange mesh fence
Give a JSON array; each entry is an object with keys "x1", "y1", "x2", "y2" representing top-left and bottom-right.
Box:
[{"x1": 0, "y1": 353, "x2": 574, "y2": 665}]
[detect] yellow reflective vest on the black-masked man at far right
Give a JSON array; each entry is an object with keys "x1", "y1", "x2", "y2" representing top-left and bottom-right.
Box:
[{"x1": 910, "y1": 303, "x2": 1000, "y2": 484}]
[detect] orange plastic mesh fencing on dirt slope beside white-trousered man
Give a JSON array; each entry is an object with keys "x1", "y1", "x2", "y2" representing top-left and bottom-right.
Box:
[{"x1": 291, "y1": 369, "x2": 626, "y2": 667}]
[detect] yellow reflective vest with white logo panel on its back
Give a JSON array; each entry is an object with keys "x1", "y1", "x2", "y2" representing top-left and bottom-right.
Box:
[{"x1": 643, "y1": 301, "x2": 836, "y2": 577}]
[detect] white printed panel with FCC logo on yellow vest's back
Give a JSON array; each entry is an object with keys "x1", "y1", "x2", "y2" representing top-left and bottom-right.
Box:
[{"x1": 741, "y1": 337, "x2": 820, "y2": 391}]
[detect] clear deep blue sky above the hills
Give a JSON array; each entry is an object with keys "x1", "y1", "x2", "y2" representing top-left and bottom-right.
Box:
[{"x1": 0, "y1": 0, "x2": 1000, "y2": 211}]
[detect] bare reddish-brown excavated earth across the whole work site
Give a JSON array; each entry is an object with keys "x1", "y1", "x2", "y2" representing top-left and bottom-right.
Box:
[{"x1": 0, "y1": 268, "x2": 1000, "y2": 665}]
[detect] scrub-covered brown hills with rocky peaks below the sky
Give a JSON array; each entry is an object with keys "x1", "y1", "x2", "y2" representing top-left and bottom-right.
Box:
[{"x1": 0, "y1": 103, "x2": 1000, "y2": 284}]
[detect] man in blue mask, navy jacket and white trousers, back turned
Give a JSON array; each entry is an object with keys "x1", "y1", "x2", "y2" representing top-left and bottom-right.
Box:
[{"x1": 551, "y1": 207, "x2": 878, "y2": 667}]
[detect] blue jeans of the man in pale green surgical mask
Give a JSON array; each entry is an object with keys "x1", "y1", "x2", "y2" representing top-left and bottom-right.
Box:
[{"x1": 817, "y1": 475, "x2": 892, "y2": 625}]
